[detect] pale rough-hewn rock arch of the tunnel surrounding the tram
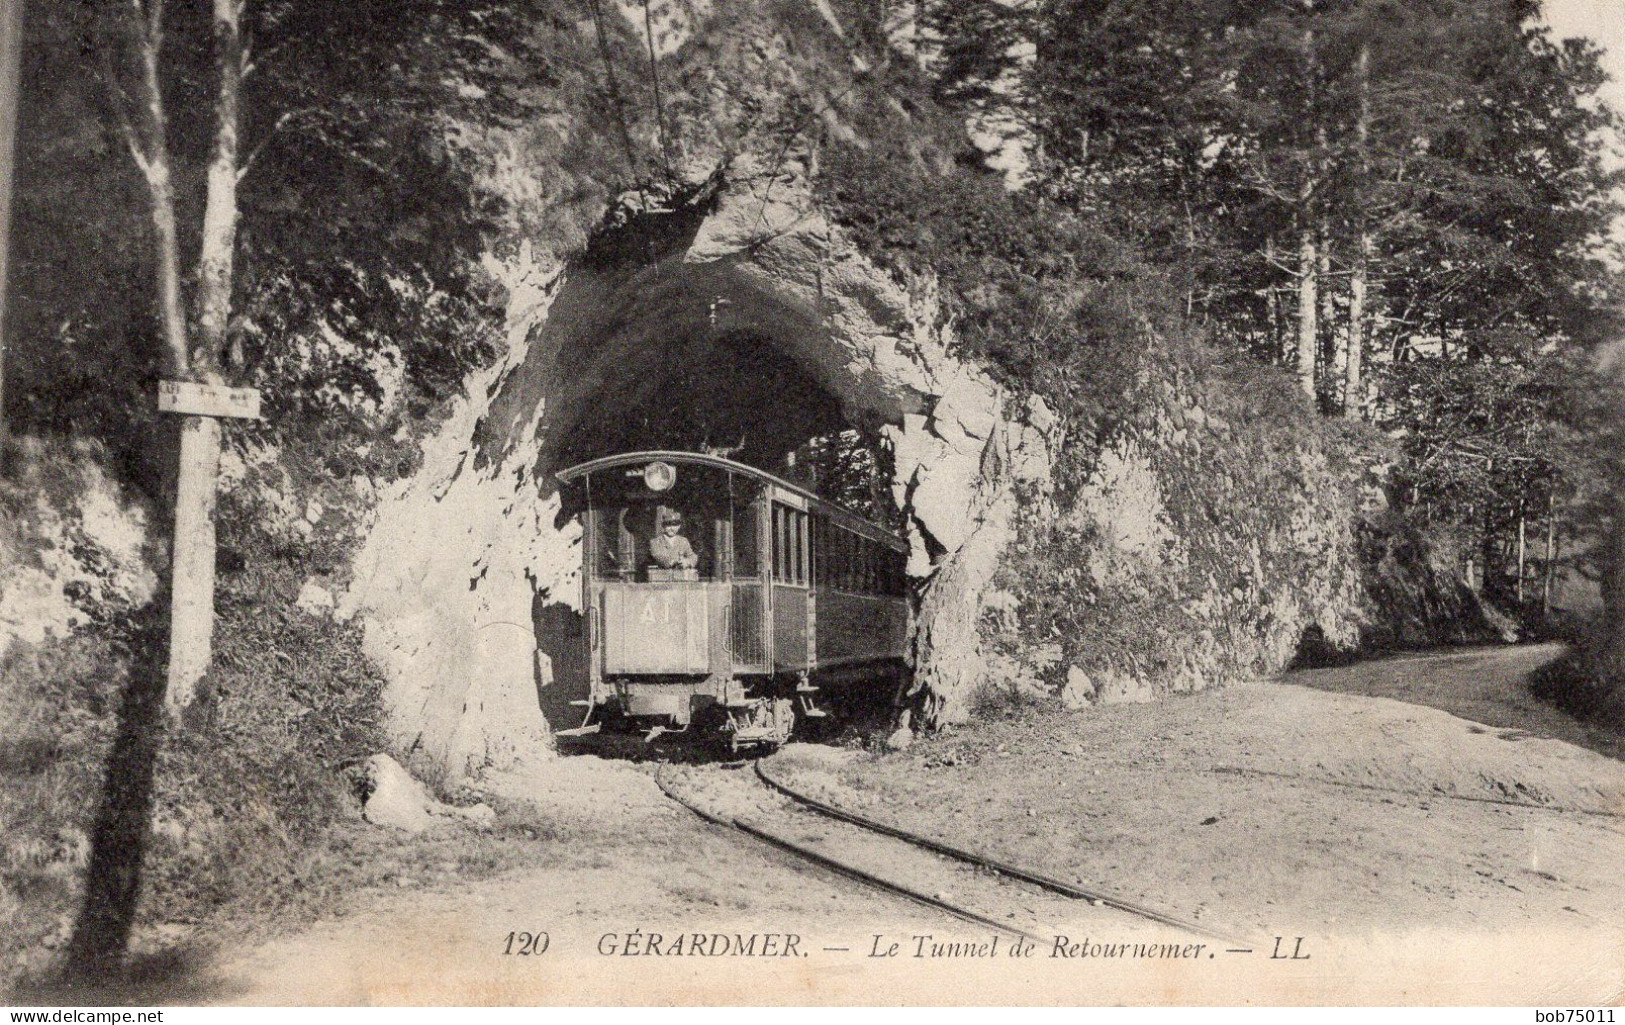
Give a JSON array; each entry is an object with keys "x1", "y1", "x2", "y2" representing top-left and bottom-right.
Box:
[{"x1": 341, "y1": 166, "x2": 1048, "y2": 776}]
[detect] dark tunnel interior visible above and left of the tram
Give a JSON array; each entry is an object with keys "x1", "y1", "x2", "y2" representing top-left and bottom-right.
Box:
[{"x1": 500, "y1": 214, "x2": 907, "y2": 731}]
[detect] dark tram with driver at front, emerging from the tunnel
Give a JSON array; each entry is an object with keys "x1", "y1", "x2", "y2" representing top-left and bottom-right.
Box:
[{"x1": 559, "y1": 452, "x2": 908, "y2": 749}]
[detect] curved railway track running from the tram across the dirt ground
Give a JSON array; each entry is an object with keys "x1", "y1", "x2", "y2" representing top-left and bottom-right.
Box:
[{"x1": 655, "y1": 760, "x2": 1240, "y2": 944}]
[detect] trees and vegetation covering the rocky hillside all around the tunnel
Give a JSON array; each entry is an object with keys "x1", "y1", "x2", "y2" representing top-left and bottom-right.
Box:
[{"x1": 0, "y1": 0, "x2": 1625, "y2": 987}]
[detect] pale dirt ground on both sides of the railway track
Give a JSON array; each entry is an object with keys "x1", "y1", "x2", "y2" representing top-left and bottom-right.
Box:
[{"x1": 196, "y1": 650, "x2": 1625, "y2": 1006}]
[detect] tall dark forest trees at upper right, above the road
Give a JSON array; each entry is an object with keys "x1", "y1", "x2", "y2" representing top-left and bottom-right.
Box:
[{"x1": 928, "y1": 0, "x2": 1620, "y2": 610}]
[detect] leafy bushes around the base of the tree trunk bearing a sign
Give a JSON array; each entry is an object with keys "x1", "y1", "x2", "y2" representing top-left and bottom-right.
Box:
[{"x1": 0, "y1": 493, "x2": 393, "y2": 984}]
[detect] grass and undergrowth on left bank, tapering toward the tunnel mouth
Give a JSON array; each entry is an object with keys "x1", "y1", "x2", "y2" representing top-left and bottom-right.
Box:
[{"x1": 0, "y1": 497, "x2": 567, "y2": 989}]
